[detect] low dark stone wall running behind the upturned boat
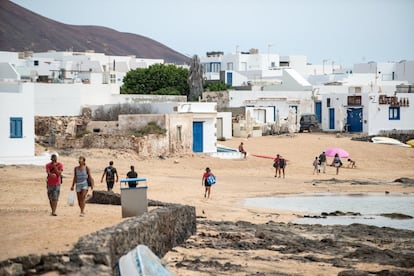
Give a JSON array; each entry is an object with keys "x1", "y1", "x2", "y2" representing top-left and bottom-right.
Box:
[{"x1": 0, "y1": 195, "x2": 196, "y2": 275}]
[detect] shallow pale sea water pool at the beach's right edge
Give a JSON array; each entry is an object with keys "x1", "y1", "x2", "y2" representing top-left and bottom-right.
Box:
[{"x1": 244, "y1": 193, "x2": 414, "y2": 230}]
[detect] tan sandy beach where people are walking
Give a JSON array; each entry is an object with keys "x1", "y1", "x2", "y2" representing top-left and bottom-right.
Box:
[{"x1": 0, "y1": 133, "x2": 414, "y2": 275}]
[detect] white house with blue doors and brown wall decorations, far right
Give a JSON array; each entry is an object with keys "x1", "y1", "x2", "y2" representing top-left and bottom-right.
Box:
[{"x1": 316, "y1": 74, "x2": 414, "y2": 135}]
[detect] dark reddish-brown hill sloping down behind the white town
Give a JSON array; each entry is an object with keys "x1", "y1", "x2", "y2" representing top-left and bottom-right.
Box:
[{"x1": 0, "y1": 0, "x2": 190, "y2": 64}]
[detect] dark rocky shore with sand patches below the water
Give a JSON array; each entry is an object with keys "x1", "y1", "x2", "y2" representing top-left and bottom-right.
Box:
[{"x1": 164, "y1": 218, "x2": 414, "y2": 276}]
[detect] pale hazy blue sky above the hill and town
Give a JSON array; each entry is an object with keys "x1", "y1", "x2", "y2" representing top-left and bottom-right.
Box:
[{"x1": 8, "y1": 0, "x2": 414, "y2": 65}]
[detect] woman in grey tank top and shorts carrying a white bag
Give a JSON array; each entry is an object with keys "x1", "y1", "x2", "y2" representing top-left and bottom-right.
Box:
[{"x1": 70, "y1": 156, "x2": 94, "y2": 217}]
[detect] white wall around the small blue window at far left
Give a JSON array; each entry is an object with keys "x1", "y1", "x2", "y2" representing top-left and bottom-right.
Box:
[{"x1": 0, "y1": 83, "x2": 35, "y2": 157}]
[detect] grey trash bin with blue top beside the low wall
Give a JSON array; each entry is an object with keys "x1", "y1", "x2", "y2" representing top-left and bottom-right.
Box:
[{"x1": 120, "y1": 178, "x2": 148, "y2": 218}]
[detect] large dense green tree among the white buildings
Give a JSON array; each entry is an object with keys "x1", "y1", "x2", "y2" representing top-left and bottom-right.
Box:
[{"x1": 121, "y1": 64, "x2": 189, "y2": 96}]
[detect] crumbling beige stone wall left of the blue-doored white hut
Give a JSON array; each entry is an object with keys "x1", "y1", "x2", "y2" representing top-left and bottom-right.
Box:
[{"x1": 35, "y1": 111, "x2": 193, "y2": 157}]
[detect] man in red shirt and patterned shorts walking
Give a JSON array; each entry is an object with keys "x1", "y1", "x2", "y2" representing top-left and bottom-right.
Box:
[{"x1": 46, "y1": 154, "x2": 63, "y2": 216}]
